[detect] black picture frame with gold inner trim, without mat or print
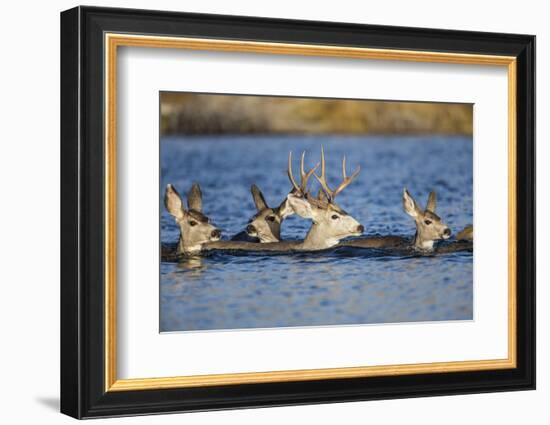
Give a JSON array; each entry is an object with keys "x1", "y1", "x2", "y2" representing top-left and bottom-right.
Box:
[{"x1": 61, "y1": 6, "x2": 536, "y2": 418}]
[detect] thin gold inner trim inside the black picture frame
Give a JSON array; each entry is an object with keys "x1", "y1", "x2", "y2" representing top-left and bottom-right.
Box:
[{"x1": 105, "y1": 33, "x2": 517, "y2": 391}]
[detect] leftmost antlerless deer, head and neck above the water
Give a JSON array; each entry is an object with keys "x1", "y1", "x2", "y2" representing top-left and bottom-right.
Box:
[{"x1": 164, "y1": 183, "x2": 221, "y2": 255}]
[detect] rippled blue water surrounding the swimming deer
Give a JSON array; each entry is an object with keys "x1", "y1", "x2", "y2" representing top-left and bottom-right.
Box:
[{"x1": 160, "y1": 136, "x2": 473, "y2": 332}]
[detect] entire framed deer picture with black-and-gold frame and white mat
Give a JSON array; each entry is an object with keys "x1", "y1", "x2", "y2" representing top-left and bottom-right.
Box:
[{"x1": 61, "y1": 7, "x2": 535, "y2": 418}]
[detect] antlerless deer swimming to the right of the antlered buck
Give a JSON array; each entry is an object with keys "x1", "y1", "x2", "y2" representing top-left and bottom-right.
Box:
[{"x1": 340, "y1": 189, "x2": 462, "y2": 252}]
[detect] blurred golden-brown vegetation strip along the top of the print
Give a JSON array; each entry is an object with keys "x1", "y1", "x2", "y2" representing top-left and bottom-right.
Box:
[{"x1": 161, "y1": 92, "x2": 473, "y2": 135}]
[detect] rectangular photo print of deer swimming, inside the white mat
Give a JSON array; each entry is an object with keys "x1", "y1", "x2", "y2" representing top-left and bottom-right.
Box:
[{"x1": 159, "y1": 92, "x2": 473, "y2": 332}]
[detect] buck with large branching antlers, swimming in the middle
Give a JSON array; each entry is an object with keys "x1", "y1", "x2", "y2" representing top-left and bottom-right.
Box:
[{"x1": 205, "y1": 149, "x2": 364, "y2": 252}]
